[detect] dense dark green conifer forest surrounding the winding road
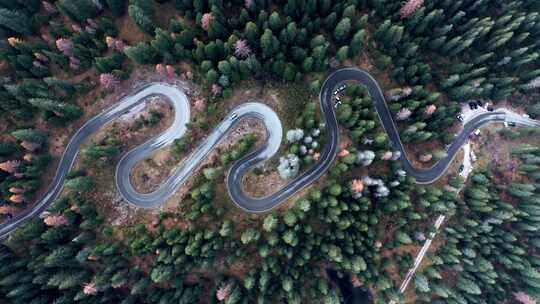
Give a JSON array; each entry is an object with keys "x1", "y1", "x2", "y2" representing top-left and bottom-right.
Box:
[{"x1": 0, "y1": 0, "x2": 540, "y2": 304}]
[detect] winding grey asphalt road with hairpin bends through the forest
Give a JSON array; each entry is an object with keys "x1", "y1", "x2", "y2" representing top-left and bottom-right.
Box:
[{"x1": 0, "y1": 68, "x2": 540, "y2": 238}]
